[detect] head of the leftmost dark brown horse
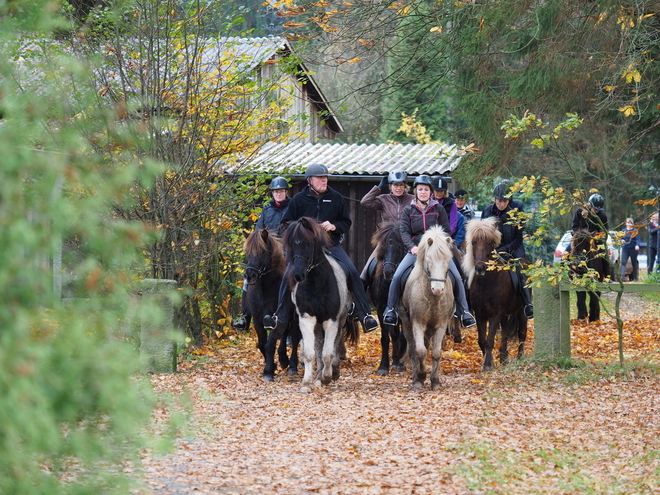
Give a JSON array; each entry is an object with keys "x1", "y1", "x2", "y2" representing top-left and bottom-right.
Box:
[{"x1": 243, "y1": 229, "x2": 285, "y2": 285}]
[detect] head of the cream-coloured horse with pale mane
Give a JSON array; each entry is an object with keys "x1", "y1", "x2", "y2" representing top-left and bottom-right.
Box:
[{"x1": 417, "y1": 226, "x2": 454, "y2": 296}]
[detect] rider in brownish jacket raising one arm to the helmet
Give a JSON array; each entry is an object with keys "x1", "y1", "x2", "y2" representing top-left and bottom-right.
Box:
[{"x1": 360, "y1": 172, "x2": 415, "y2": 288}]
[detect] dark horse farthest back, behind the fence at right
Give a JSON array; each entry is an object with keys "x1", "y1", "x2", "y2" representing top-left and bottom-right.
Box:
[{"x1": 568, "y1": 229, "x2": 610, "y2": 322}]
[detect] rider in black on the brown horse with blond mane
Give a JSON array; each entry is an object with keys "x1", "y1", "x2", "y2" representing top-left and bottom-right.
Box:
[{"x1": 481, "y1": 180, "x2": 534, "y2": 318}]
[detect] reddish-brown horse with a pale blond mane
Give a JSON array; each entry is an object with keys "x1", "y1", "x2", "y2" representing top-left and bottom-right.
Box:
[{"x1": 462, "y1": 217, "x2": 527, "y2": 371}]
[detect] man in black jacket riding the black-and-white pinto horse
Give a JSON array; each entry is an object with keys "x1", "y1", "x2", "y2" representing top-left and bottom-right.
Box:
[{"x1": 264, "y1": 163, "x2": 378, "y2": 333}]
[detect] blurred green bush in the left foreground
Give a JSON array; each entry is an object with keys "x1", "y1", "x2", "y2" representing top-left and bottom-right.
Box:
[{"x1": 0, "y1": 0, "x2": 178, "y2": 494}]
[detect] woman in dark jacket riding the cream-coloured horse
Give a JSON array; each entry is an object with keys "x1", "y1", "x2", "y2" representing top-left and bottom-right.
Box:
[{"x1": 383, "y1": 175, "x2": 476, "y2": 328}]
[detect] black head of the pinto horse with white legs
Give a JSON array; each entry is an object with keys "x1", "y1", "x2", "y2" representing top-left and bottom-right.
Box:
[{"x1": 284, "y1": 217, "x2": 330, "y2": 283}]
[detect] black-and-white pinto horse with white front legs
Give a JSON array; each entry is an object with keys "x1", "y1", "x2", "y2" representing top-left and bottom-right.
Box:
[{"x1": 283, "y1": 217, "x2": 359, "y2": 393}]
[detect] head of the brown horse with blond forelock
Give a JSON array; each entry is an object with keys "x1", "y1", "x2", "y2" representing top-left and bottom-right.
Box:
[{"x1": 463, "y1": 217, "x2": 502, "y2": 276}]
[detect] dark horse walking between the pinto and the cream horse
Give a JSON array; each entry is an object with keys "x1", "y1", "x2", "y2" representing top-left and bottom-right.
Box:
[{"x1": 368, "y1": 223, "x2": 406, "y2": 375}]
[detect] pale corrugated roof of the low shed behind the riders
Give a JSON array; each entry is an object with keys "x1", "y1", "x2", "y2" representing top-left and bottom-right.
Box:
[{"x1": 240, "y1": 143, "x2": 461, "y2": 175}]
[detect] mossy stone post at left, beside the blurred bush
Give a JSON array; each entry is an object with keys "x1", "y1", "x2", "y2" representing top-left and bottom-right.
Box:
[{"x1": 140, "y1": 278, "x2": 177, "y2": 373}]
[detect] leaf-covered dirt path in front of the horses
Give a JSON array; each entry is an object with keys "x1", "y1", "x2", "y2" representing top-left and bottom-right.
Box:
[{"x1": 136, "y1": 296, "x2": 660, "y2": 495}]
